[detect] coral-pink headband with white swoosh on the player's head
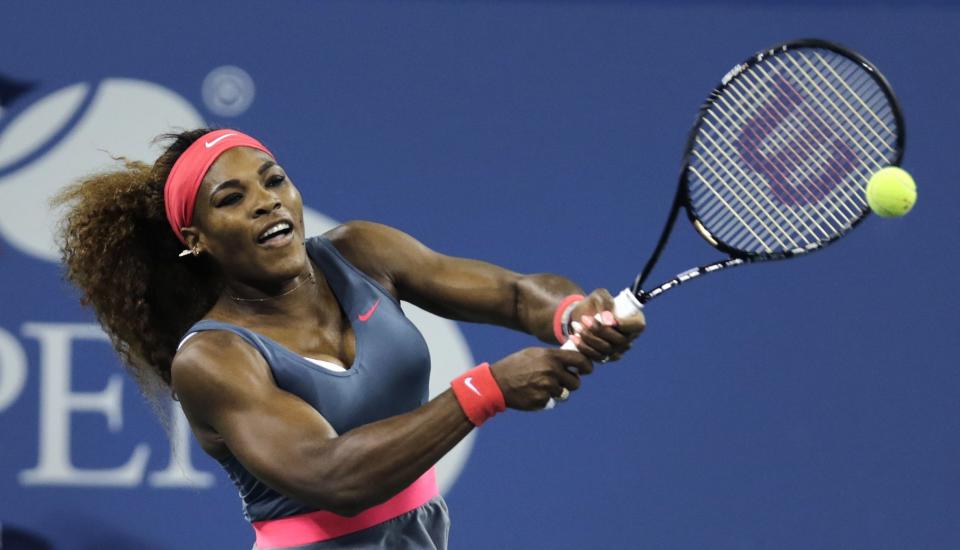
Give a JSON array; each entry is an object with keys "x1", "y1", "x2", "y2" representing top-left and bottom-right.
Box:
[{"x1": 163, "y1": 130, "x2": 273, "y2": 244}]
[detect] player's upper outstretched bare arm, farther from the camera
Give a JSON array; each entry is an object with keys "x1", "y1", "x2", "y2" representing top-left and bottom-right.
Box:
[{"x1": 329, "y1": 222, "x2": 584, "y2": 344}]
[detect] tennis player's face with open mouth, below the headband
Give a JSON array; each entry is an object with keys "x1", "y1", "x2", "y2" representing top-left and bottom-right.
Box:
[{"x1": 183, "y1": 147, "x2": 307, "y2": 284}]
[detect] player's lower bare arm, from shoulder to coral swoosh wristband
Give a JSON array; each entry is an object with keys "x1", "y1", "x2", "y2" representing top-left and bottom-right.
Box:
[{"x1": 173, "y1": 332, "x2": 473, "y2": 515}]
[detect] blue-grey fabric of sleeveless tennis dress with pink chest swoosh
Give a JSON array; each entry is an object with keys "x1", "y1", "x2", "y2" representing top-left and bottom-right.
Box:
[{"x1": 181, "y1": 236, "x2": 448, "y2": 547}]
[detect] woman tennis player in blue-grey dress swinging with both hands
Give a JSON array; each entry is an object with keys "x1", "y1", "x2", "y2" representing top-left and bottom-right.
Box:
[{"x1": 54, "y1": 129, "x2": 644, "y2": 550}]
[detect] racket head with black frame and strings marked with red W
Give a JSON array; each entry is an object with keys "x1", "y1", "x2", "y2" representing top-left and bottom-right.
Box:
[{"x1": 678, "y1": 39, "x2": 905, "y2": 261}]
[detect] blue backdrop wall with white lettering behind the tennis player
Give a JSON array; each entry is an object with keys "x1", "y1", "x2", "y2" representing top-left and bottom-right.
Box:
[{"x1": 0, "y1": 0, "x2": 960, "y2": 550}]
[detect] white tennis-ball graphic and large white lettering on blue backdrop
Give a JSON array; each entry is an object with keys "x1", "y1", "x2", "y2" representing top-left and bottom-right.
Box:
[{"x1": 0, "y1": 77, "x2": 474, "y2": 491}]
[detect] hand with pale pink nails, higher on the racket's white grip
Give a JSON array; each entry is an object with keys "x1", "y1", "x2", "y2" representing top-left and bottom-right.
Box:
[{"x1": 570, "y1": 288, "x2": 647, "y2": 363}]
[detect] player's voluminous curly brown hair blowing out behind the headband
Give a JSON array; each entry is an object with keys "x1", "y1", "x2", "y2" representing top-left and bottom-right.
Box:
[{"x1": 51, "y1": 128, "x2": 222, "y2": 398}]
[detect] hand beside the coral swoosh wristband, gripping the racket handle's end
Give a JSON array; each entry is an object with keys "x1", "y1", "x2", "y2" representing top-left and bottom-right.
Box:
[{"x1": 490, "y1": 348, "x2": 593, "y2": 411}]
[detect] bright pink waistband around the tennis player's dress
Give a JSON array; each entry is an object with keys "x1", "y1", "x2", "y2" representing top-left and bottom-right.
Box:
[{"x1": 253, "y1": 468, "x2": 440, "y2": 548}]
